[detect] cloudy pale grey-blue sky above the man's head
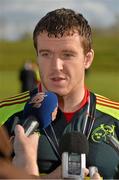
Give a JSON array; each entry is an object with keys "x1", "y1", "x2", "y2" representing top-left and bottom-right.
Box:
[{"x1": 0, "y1": 0, "x2": 119, "y2": 39}]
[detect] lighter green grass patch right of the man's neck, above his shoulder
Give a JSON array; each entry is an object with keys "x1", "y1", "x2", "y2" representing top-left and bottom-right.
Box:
[{"x1": 86, "y1": 72, "x2": 119, "y2": 101}]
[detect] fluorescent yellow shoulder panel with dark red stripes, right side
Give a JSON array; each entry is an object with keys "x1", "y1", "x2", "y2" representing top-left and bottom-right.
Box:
[{"x1": 95, "y1": 94, "x2": 119, "y2": 120}]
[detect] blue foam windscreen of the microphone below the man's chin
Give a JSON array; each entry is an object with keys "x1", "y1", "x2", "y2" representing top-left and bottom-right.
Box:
[{"x1": 23, "y1": 91, "x2": 58, "y2": 129}]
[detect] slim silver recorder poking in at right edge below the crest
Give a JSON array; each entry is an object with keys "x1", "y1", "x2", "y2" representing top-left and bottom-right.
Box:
[{"x1": 106, "y1": 134, "x2": 119, "y2": 155}]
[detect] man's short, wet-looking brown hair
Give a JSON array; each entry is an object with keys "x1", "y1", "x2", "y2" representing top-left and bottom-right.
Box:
[{"x1": 33, "y1": 8, "x2": 92, "y2": 53}]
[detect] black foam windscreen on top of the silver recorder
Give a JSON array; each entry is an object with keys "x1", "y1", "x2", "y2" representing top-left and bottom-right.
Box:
[{"x1": 59, "y1": 131, "x2": 89, "y2": 155}]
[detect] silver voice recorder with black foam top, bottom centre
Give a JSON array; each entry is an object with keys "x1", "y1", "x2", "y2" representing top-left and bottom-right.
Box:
[{"x1": 59, "y1": 131, "x2": 89, "y2": 179}]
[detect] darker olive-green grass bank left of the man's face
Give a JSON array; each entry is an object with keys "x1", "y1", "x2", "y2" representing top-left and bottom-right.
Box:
[{"x1": 0, "y1": 38, "x2": 35, "y2": 71}]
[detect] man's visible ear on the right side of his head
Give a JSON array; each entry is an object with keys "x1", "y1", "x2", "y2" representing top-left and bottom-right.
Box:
[{"x1": 84, "y1": 49, "x2": 94, "y2": 69}]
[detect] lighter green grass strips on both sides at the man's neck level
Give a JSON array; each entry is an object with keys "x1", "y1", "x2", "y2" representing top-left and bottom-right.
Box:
[{"x1": 0, "y1": 71, "x2": 119, "y2": 101}]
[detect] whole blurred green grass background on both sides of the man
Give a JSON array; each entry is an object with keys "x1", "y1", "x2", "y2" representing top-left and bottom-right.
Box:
[{"x1": 0, "y1": 32, "x2": 119, "y2": 101}]
